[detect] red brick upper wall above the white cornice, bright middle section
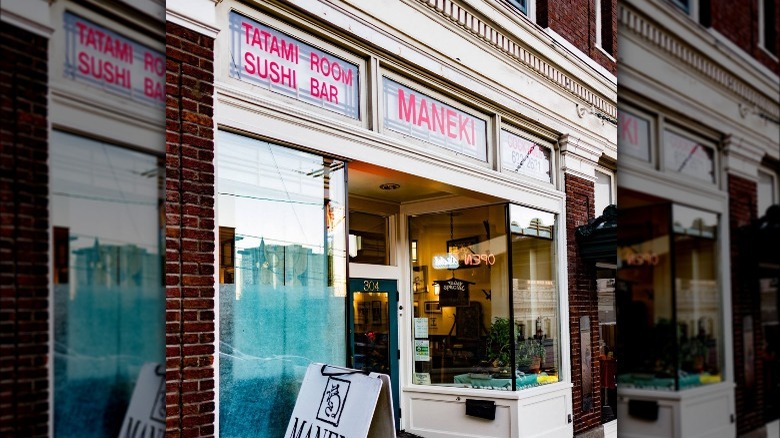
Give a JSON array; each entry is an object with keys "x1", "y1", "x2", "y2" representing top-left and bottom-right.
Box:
[{"x1": 536, "y1": 0, "x2": 617, "y2": 74}]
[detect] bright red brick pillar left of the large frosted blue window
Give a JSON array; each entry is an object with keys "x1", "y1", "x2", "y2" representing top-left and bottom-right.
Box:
[{"x1": 165, "y1": 22, "x2": 215, "y2": 437}]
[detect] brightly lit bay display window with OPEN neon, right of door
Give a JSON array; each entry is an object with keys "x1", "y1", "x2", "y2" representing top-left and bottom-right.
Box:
[{"x1": 409, "y1": 205, "x2": 560, "y2": 390}]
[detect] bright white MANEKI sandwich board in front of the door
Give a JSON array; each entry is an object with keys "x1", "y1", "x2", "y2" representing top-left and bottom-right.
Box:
[{"x1": 284, "y1": 363, "x2": 395, "y2": 438}]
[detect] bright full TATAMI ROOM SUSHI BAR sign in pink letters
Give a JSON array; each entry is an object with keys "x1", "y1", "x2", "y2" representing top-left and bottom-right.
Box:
[{"x1": 230, "y1": 12, "x2": 360, "y2": 119}]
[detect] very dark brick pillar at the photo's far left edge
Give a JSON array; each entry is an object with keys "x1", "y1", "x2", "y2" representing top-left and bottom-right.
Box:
[{"x1": 0, "y1": 22, "x2": 50, "y2": 437}]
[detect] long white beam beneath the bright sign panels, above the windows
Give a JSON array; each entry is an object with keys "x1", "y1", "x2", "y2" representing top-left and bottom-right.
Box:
[{"x1": 215, "y1": 84, "x2": 564, "y2": 211}]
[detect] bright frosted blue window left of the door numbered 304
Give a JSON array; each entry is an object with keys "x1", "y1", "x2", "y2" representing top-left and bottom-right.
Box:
[{"x1": 217, "y1": 132, "x2": 347, "y2": 437}]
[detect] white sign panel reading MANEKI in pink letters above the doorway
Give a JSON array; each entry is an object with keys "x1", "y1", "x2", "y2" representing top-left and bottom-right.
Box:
[{"x1": 382, "y1": 78, "x2": 487, "y2": 161}]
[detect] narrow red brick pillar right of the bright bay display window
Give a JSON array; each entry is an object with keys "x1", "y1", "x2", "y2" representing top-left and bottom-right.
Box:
[{"x1": 565, "y1": 174, "x2": 601, "y2": 435}]
